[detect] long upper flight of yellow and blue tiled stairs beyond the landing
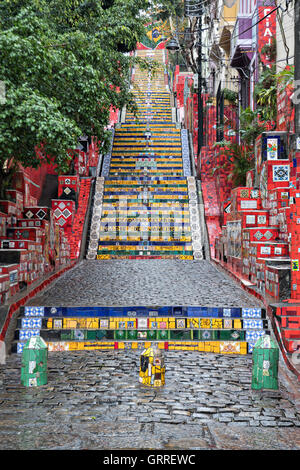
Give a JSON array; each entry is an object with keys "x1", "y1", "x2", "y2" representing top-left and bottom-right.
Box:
[{"x1": 87, "y1": 51, "x2": 202, "y2": 259}]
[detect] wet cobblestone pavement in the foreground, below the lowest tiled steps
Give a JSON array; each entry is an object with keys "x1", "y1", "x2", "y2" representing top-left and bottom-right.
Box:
[{"x1": 0, "y1": 351, "x2": 300, "y2": 450}]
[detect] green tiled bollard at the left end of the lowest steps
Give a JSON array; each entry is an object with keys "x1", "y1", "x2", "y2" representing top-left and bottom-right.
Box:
[{"x1": 21, "y1": 336, "x2": 48, "y2": 387}]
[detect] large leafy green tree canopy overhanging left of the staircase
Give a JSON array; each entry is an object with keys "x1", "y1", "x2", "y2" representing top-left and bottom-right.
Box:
[{"x1": 0, "y1": 0, "x2": 148, "y2": 171}]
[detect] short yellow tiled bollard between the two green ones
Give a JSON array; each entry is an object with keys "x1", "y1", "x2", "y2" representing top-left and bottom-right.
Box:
[{"x1": 139, "y1": 346, "x2": 165, "y2": 387}]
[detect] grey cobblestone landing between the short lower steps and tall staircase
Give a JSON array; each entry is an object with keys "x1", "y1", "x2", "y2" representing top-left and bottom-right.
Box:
[{"x1": 30, "y1": 260, "x2": 260, "y2": 307}]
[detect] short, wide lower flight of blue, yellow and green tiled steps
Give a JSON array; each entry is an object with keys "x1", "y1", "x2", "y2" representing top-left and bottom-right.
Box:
[{"x1": 12, "y1": 306, "x2": 269, "y2": 354}]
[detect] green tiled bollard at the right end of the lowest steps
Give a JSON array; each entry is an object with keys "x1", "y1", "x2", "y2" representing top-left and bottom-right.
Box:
[{"x1": 251, "y1": 335, "x2": 279, "y2": 390}]
